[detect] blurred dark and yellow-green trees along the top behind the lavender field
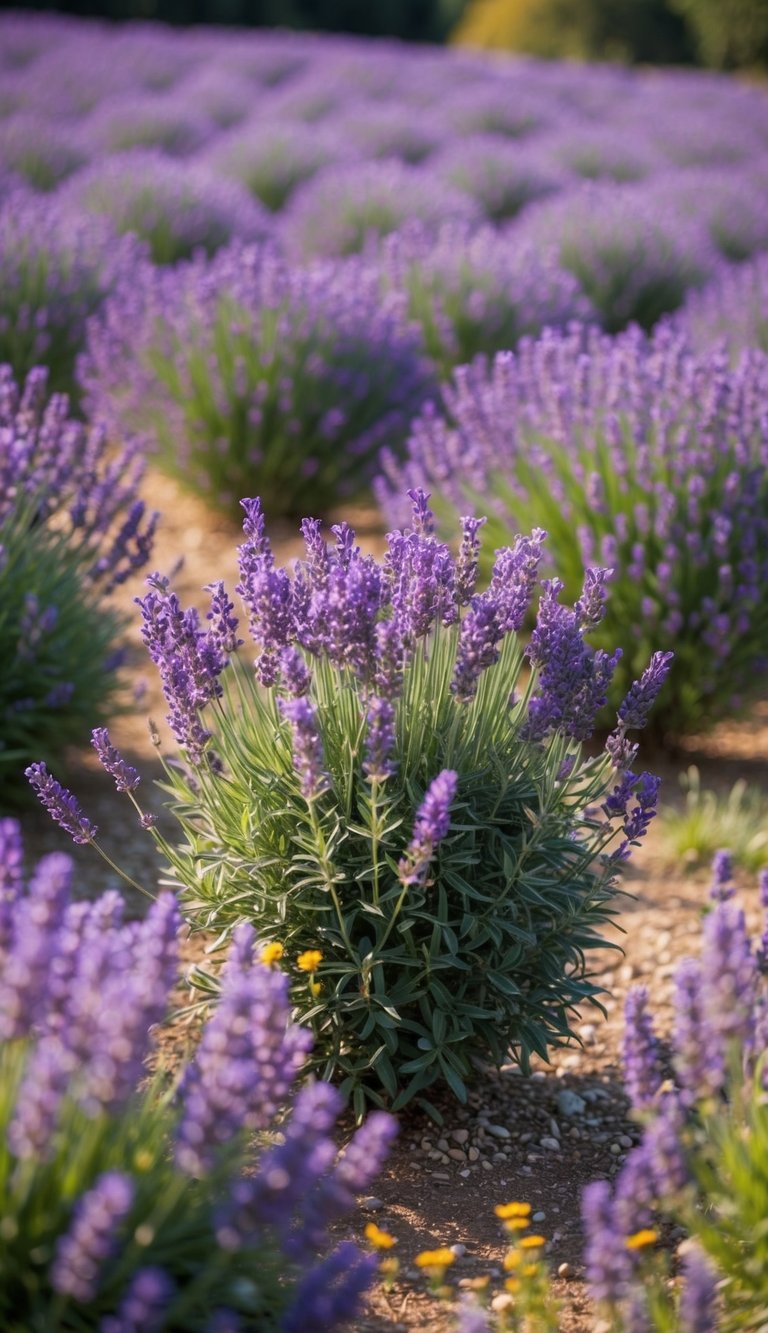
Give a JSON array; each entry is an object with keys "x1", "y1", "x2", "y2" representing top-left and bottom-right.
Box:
[{"x1": 9, "y1": 0, "x2": 768, "y2": 71}]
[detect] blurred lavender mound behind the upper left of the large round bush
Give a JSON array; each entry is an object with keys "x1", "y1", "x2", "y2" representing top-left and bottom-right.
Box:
[{"x1": 61, "y1": 148, "x2": 272, "y2": 264}]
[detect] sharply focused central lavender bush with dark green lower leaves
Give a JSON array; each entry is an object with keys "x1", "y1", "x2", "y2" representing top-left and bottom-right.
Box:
[{"x1": 30, "y1": 492, "x2": 665, "y2": 1114}]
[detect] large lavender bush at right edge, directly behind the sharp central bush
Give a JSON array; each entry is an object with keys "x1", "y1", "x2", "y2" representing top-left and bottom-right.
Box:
[{"x1": 377, "y1": 328, "x2": 768, "y2": 733}]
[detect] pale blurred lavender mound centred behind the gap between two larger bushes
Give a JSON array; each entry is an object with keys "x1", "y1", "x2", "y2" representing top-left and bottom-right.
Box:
[{"x1": 278, "y1": 161, "x2": 480, "y2": 256}]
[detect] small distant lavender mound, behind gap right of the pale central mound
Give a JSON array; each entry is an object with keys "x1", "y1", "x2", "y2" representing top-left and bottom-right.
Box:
[{"x1": 432, "y1": 135, "x2": 567, "y2": 223}]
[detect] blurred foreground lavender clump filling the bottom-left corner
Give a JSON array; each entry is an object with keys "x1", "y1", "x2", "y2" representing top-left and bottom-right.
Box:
[{"x1": 0, "y1": 820, "x2": 395, "y2": 1333}]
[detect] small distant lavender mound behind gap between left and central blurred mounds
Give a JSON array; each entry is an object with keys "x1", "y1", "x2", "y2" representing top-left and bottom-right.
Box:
[{"x1": 207, "y1": 115, "x2": 349, "y2": 212}]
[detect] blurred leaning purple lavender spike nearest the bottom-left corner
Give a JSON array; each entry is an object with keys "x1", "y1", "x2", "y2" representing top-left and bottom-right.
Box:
[{"x1": 51, "y1": 1170, "x2": 133, "y2": 1302}]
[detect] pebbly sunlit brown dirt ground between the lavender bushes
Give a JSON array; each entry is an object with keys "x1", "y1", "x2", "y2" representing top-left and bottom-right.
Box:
[{"x1": 16, "y1": 475, "x2": 768, "y2": 1333}]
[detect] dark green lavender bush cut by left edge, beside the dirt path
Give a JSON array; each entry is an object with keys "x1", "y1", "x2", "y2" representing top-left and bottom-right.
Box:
[{"x1": 0, "y1": 365, "x2": 155, "y2": 800}]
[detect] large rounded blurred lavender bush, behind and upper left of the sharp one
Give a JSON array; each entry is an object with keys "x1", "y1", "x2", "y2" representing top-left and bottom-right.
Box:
[{"x1": 81, "y1": 245, "x2": 435, "y2": 513}]
